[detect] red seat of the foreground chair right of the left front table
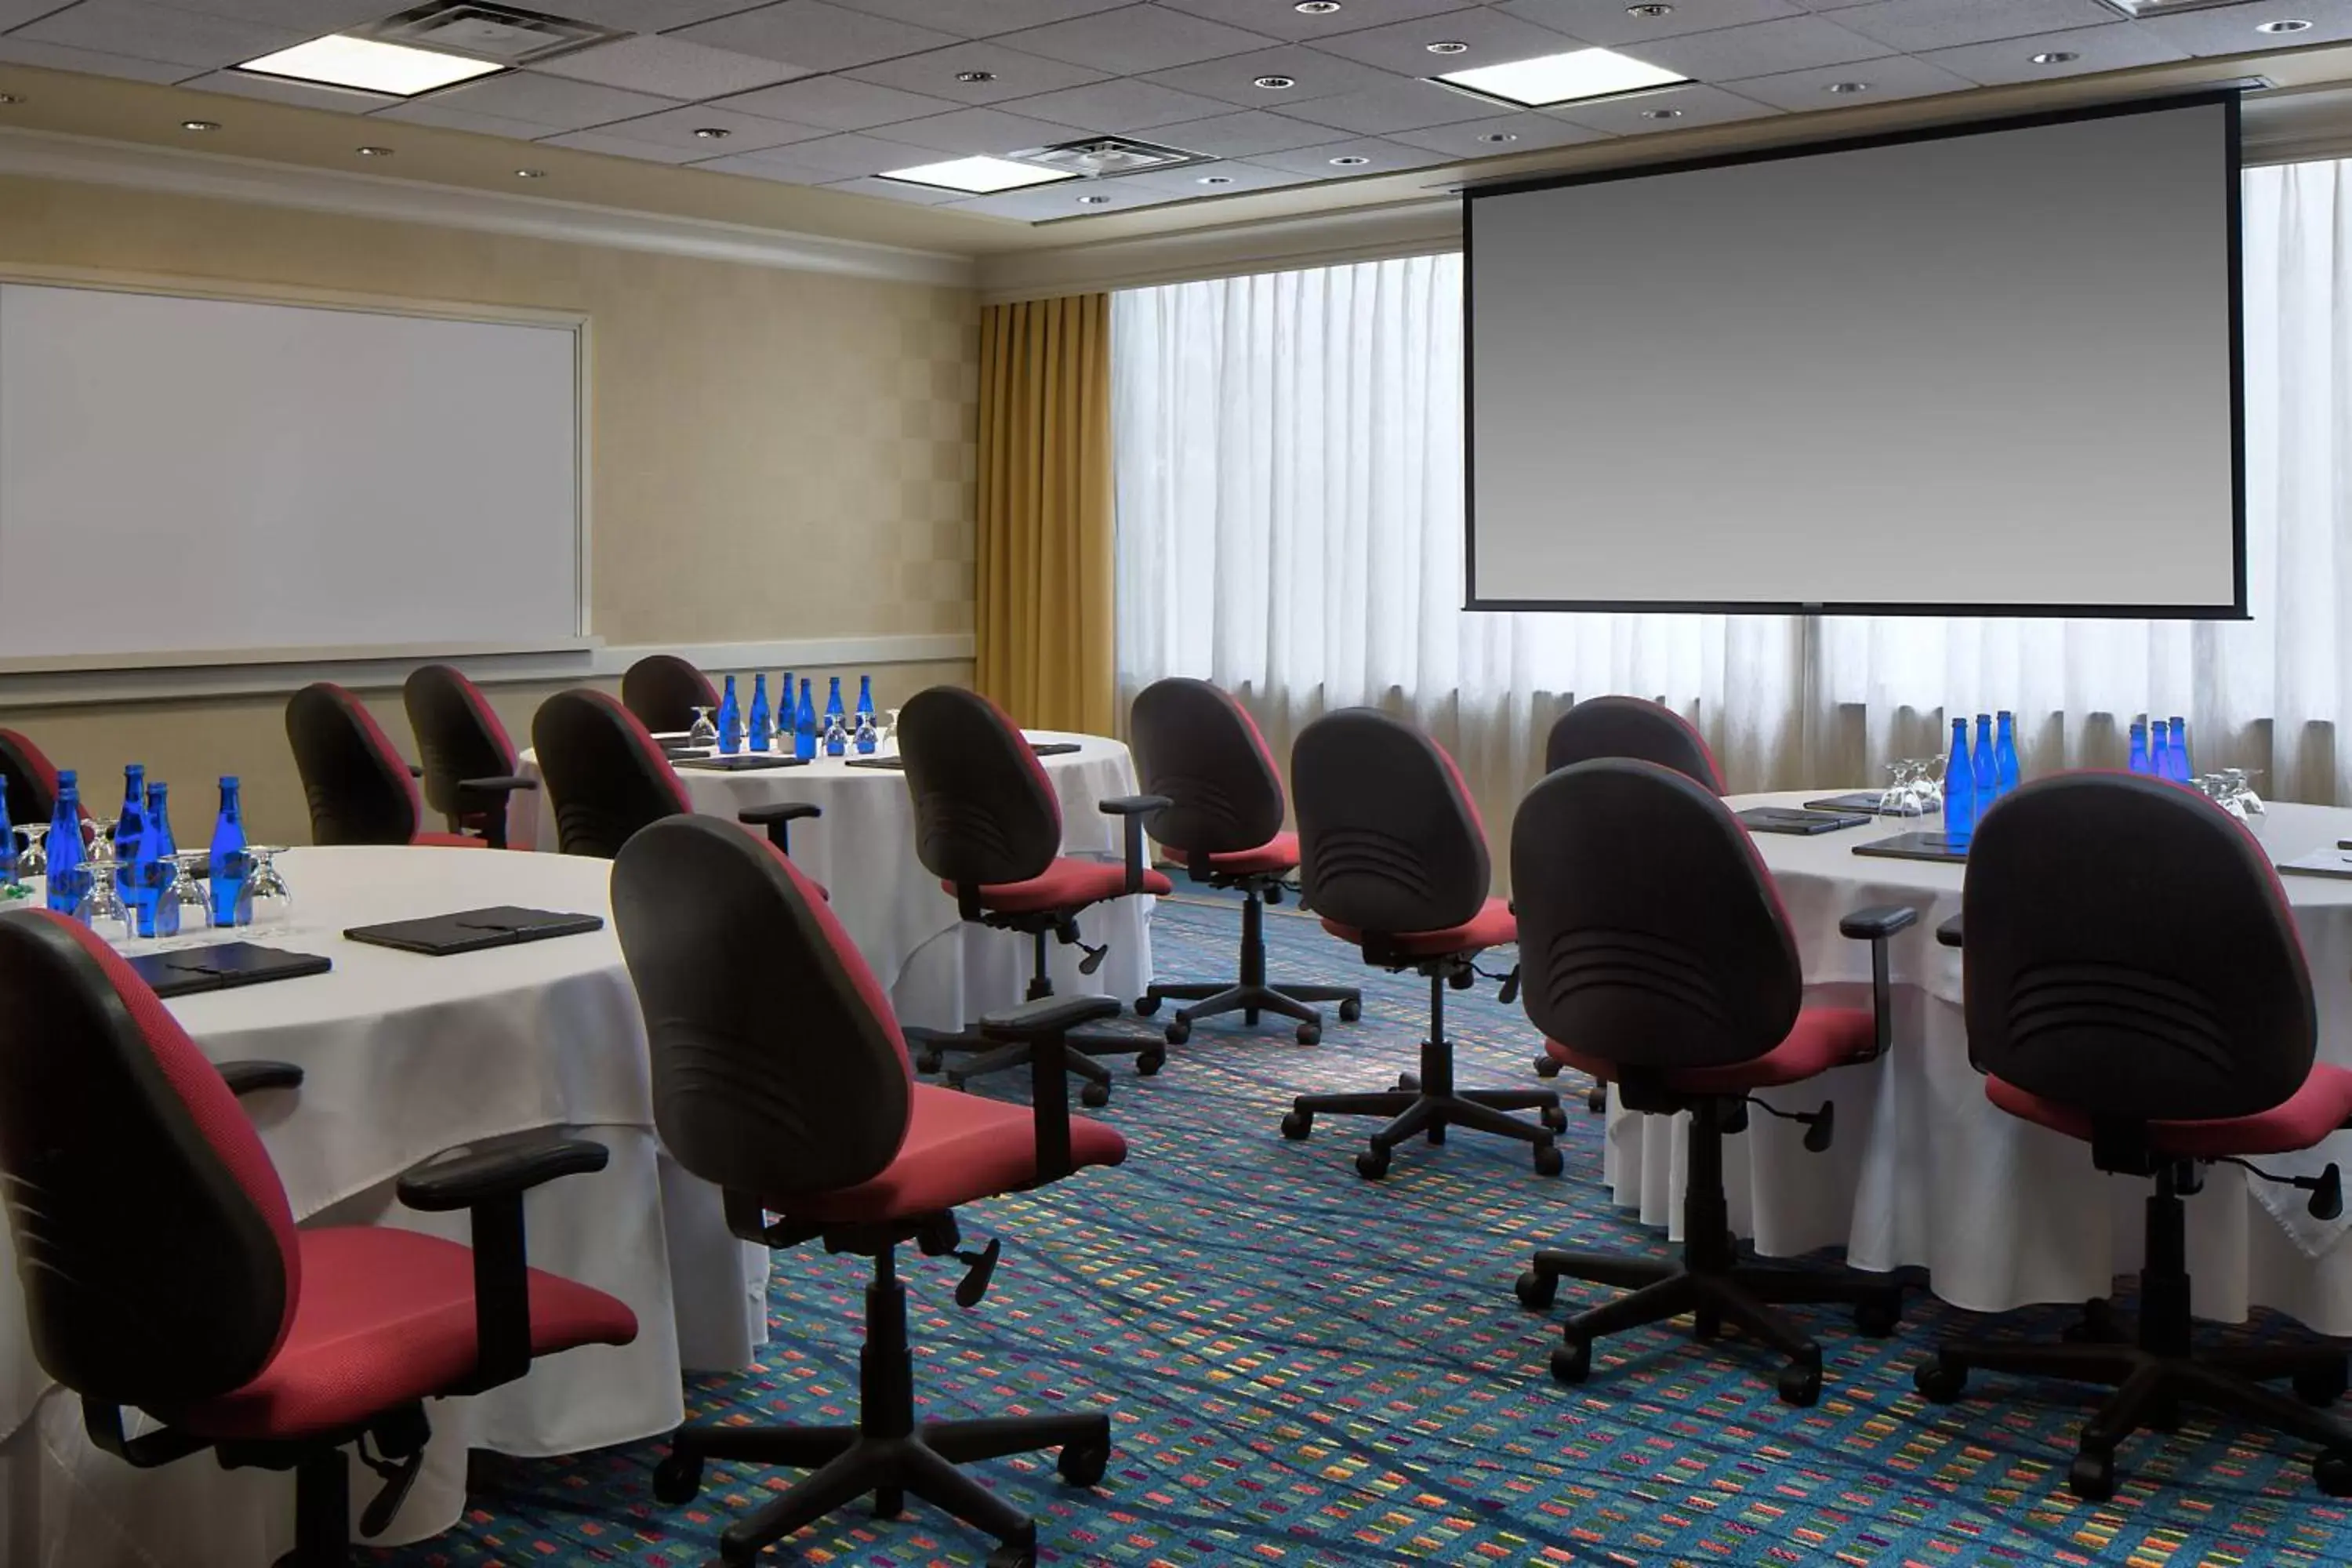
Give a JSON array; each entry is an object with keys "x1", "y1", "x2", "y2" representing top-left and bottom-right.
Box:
[{"x1": 769, "y1": 1083, "x2": 1127, "y2": 1225}]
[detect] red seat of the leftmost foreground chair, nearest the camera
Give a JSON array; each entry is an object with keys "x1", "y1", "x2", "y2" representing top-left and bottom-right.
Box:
[{"x1": 172, "y1": 1225, "x2": 637, "y2": 1439}]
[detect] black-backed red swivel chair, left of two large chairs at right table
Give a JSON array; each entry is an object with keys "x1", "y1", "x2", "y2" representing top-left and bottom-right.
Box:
[{"x1": 1510, "y1": 760, "x2": 1910, "y2": 1406}]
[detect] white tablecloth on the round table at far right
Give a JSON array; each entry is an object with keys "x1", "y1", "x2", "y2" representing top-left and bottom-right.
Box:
[{"x1": 1604, "y1": 789, "x2": 2352, "y2": 1335}]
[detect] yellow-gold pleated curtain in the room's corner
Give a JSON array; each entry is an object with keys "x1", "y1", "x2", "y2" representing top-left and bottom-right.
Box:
[{"x1": 976, "y1": 294, "x2": 1115, "y2": 736}]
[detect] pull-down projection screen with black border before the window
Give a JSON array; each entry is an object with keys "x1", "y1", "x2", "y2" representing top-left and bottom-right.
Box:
[{"x1": 1465, "y1": 94, "x2": 2244, "y2": 619}]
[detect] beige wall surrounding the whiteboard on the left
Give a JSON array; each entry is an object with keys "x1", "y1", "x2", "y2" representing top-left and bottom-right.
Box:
[{"x1": 0, "y1": 179, "x2": 978, "y2": 841}]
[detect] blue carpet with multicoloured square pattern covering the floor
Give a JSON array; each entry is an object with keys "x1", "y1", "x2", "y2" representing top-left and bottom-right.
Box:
[{"x1": 369, "y1": 898, "x2": 2352, "y2": 1568}]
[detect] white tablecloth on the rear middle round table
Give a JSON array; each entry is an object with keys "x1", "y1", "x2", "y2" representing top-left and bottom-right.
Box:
[{"x1": 508, "y1": 731, "x2": 1152, "y2": 1029}]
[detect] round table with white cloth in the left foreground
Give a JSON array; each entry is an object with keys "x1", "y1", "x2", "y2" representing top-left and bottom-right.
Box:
[{"x1": 0, "y1": 846, "x2": 767, "y2": 1568}]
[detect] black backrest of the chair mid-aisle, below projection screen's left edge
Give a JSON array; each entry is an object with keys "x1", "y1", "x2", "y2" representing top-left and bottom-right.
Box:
[{"x1": 1291, "y1": 708, "x2": 1491, "y2": 933}]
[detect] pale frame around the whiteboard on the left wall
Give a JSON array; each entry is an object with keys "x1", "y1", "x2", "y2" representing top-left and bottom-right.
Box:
[{"x1": 0, "y1": 263, "x2": 602, "y2": 675}]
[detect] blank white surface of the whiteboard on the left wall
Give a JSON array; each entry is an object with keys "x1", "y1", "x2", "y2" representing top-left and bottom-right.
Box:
[{"x1": 0, "y1": 285, "x2": 586, "y2": 661}]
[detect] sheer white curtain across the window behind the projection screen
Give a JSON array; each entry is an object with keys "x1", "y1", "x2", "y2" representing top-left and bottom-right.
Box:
[{"x1": 1112, "y1": 162, "x2": 2352, "y2": 832}]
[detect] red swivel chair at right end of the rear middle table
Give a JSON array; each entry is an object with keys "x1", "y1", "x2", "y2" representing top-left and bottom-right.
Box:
[{"x1": 1127, "y1": 677, "x2": 1364, "y2": 1046}]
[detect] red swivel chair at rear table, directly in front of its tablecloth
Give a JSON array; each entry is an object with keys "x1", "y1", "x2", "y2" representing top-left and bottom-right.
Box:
[{"x1": 896, "y1": 687, "x2": 1174, "y2": 1105}]
